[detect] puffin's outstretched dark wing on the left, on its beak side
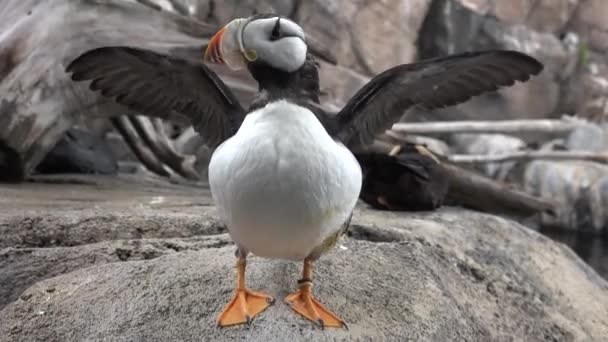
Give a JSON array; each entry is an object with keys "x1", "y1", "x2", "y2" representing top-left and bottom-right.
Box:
[{"x1": 66, "y1": 46, "x2": 245, "y2": 147}]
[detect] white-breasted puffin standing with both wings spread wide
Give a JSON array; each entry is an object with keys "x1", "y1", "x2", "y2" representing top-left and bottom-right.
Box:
[{"x1": 66, "y1": 13, "x2": 543, "y2": 328}]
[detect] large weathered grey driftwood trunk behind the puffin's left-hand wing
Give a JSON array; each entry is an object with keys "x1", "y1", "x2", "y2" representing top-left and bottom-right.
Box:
[{"x1": 0, "y1": 0, "x2": 335, "y2": 181}]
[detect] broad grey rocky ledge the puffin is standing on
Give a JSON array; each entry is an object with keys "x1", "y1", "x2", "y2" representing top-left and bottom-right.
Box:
[{"x1": 0, "y1": 177, "x2": 608, "y2": 341}]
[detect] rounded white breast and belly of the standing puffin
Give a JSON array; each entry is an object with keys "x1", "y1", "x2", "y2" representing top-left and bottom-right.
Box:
[{"x1": 209, "y1": 101, "x2": 361, "y2": 260}]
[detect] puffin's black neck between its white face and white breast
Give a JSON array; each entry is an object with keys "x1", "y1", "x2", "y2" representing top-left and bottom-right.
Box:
[{"x1": 249, "y1": 55, "x2": 319, "y2": 107}]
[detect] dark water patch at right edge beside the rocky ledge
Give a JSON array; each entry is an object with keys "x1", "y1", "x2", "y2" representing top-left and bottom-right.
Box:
[{"x1": 541, "y1": 231, "x2": 608, "y2": 280}]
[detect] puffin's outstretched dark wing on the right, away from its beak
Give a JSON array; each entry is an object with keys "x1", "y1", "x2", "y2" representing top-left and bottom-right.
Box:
[{"x1": 332, "y1": 50, "x2": 543, "y2": 147}]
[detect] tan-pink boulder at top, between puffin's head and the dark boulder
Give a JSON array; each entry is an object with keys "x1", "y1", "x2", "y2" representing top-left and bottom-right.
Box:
[{"x1": 295, "y1": 0, "x2": 431, "y2": 76}]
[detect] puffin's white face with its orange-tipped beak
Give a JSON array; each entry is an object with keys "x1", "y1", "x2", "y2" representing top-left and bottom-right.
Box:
[{"x1": 205, "y1": 17, "x2": 308, "y2": 72}]
